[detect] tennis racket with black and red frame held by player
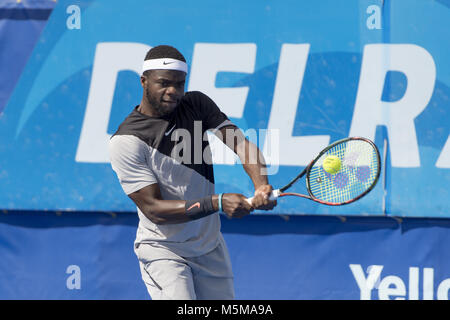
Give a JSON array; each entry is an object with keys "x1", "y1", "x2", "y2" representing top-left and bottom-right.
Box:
[{"x1": 247, "y1": 137, "x2": 381, "y2": 206}]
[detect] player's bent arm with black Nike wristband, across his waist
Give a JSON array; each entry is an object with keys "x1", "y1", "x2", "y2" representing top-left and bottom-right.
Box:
[{"x1": 128, "y1": 183, "x2": 253, "y2": 224}]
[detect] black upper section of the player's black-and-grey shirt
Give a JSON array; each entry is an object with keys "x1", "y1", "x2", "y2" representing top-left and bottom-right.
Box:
[{"x1": 113, "y1": 91, "x2": 232, "y2": 183}]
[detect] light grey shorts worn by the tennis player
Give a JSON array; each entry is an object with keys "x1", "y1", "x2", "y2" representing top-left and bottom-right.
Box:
[{"x1": 135, "y1": 235, "x2": 234, "y2": 300}]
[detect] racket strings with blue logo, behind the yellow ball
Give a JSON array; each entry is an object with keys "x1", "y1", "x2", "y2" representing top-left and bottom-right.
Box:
[{"x1": 307, "y1": 140, "x2": 379, "y2": 203}]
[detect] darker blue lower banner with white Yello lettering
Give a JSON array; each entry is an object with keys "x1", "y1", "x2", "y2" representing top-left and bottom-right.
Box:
[{"x1": 0, "y1": 212, "x2": 450, "y2": 300}]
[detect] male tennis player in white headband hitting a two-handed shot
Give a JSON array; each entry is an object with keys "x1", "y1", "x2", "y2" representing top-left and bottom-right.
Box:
[{"x1": 110, "y1": 45, "x2": 276, "y2": 299}]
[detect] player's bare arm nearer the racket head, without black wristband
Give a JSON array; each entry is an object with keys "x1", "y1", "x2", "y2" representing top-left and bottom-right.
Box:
[{"x1": 216, "y1": 125, "x2": 276, "y2": 210}]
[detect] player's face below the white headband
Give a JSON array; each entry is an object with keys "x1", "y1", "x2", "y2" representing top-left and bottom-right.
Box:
[{"x1": 142, "y1": 70, "x2": 186, "y2": 116}]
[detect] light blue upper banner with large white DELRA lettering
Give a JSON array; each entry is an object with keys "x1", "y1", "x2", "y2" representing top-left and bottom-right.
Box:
[{"x1": 0, "y1": 0, "x2": 450, "y2": 217}]
